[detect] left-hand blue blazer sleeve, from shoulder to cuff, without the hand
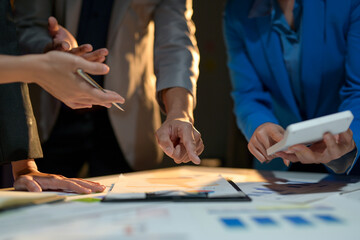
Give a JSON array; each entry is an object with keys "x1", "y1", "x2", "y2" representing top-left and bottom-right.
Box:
[{"x1": 224, "y1": 1, "x2": 278, "y2": 140}]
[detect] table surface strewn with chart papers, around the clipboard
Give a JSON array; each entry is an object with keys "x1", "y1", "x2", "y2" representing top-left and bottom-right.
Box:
[{"x1": 0, "y1": 166, "x2": 360, "y2": 240}]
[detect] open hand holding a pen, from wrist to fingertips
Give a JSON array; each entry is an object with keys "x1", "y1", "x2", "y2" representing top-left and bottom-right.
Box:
[{"x1": 31, "y1": 51, "x2": 125, "y2": 109}]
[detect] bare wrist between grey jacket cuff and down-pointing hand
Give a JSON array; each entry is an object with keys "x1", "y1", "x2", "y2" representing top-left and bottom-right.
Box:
[{"x1": 162, "y1": 87, "x2": 194, "y2": 123}]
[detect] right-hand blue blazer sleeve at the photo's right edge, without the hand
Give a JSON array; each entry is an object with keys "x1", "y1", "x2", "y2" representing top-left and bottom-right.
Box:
[{"x1": 339, "y1": 0, "x2": 360, "y2": 174}]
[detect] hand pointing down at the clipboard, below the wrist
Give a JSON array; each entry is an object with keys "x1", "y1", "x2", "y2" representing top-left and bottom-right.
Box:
[{"x1": 156, "y1": 116, "x2": 204, "y2": 164}]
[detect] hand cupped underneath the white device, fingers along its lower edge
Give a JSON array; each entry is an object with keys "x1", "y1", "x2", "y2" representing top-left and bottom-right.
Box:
[{"x1": 275, "y1": 129, "x2": 355, "y2": 164}]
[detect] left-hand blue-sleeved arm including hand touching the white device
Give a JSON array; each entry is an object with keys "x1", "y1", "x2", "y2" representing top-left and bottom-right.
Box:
[{"x1": 224, "y1": 1, "x2": 284, "y2": 162}]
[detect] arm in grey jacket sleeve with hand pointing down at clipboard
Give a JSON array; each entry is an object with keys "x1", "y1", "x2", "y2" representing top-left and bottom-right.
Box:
[{"x1": 154, "y1": 0, "x2": 204, "y2": 164}]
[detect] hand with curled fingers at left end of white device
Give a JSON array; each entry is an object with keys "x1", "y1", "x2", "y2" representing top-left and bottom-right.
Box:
[{"x1": 248, "y1": 123, "x2": 289, "y2": 166}]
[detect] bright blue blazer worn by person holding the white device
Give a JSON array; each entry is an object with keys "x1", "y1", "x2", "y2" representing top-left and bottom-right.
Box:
[{"x1": 224, "y1": 0, "x2": 360, "y2": 174}]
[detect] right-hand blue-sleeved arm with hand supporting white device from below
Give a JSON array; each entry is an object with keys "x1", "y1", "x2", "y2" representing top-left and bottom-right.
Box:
[{"x1": 277, "y1": 0, "x2": 360, "y2": 173}]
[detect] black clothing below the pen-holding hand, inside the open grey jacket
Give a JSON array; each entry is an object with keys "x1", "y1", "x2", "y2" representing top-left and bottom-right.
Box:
[{"x1": 36, "y1": 106, "x2": 132, "y2": 177}]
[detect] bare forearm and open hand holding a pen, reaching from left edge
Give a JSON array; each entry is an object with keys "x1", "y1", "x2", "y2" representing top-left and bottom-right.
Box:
[{"x1": 0, "y1": 51, "x2": 124, "y2": 108}]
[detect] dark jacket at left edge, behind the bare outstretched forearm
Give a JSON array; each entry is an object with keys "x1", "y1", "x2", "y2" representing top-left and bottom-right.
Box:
[{"x1": 0, "y1": 0, "x2": 42, "y2": 164}]
